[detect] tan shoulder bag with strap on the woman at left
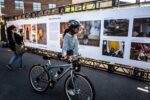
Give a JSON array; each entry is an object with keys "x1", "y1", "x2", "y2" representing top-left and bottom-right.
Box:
[{"x1": 12, "y1": 33, "x2": 26, "y2": 55}]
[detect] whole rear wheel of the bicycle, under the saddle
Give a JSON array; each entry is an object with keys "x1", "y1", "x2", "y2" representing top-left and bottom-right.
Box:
[{"x1": 29, "y1": 65, "x2": 50, "y2": 93}]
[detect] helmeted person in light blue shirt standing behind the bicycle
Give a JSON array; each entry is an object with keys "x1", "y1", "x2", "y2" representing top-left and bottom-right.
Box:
[{"x1": 62, "y1": 20, "x2": 81, "y2": 95}]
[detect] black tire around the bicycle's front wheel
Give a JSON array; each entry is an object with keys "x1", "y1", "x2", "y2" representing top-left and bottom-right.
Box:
[{"x1": 64, "y1": 73, "x2": 95, "y2": 100}]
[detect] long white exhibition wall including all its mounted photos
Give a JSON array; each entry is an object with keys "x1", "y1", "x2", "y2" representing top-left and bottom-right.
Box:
[{"x1": 7, "y1": 7, "x2": 150, "y2": 68}]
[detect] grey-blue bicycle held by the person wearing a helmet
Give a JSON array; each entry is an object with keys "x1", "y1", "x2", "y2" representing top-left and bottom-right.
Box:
[{"x1": 29, "y1": 56, "x2": 95, "y2": 100}]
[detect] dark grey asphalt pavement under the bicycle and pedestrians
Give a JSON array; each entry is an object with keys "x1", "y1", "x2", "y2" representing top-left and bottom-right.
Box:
[{"x1": 0, "y1": 46, "x2": 150, "y2": 100}]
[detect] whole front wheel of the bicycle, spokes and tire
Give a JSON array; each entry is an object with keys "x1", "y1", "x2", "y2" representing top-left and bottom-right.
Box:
[{"x1": 64, "y1": 73, "x2": 95, "y2": 100}]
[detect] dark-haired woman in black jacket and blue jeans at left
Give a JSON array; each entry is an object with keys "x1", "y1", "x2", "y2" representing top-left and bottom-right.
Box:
[{"x1": 6, "y1": 25, "x2": 23, "y2": 70}]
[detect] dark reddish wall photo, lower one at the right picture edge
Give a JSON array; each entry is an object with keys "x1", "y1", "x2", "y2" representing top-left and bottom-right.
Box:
[{"x1": 130, "y1": 42, "x2": 150, "y2": 62}]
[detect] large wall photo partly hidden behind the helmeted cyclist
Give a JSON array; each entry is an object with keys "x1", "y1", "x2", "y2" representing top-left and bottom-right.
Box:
[{"x1": 60, "y1": 20, "x2": 101, "y2": 46}]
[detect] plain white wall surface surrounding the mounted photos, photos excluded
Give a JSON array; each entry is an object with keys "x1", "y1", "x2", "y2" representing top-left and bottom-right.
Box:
[{"x1": 8, "y1": 7, "x2": 150, "y2": 68}]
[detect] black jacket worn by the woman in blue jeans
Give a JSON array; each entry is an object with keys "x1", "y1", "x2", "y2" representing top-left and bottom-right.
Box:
[{"x1": 7, "y1": 31, "x2": 23, "y2": 51}]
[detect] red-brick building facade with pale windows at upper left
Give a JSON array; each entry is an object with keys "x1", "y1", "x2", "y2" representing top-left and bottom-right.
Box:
[{"x1": 0, "y1": 0, "x2": 72, "y2": 16}]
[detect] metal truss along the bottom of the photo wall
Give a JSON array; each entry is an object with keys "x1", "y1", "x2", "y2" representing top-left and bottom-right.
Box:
[{"x1": 27, "y1": 47, "x2": 150, "y2": 82}]
